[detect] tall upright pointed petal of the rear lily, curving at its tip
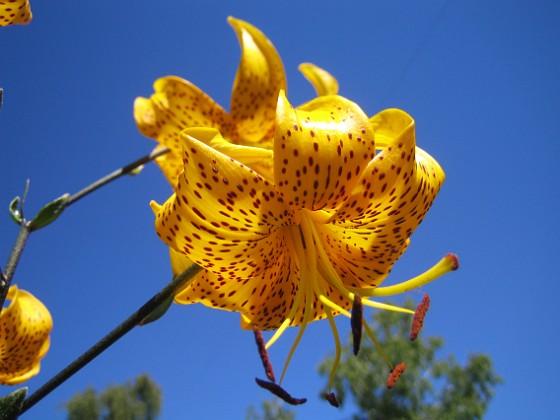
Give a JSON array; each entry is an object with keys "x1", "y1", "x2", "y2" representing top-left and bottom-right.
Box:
[{"x1": 228, "y1": 17, "x2": 286, "y2": 143}]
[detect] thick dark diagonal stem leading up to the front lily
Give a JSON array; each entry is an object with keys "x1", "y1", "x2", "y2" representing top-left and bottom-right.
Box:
[{"x1": 21, "y1": 264, "x2": 202, "y2": 414}]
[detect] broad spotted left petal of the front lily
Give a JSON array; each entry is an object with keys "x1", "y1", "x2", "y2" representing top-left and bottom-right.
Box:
[{"x1": 152, "y1": 129, "x2": 295, "y2": 279}]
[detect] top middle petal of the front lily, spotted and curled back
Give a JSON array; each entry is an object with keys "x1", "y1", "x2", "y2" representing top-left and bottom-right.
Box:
[{"x1": 274, "y1": 92, "x2": 375, "y2": 210}]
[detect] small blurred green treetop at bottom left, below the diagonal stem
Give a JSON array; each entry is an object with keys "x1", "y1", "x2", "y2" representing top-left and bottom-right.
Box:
[{"x1": 64, "y1": 375, "x2": 161, "y2": 420}]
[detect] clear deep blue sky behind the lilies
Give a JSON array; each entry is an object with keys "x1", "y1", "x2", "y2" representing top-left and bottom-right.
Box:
[{"x1": 0, "y1": 0, "x2": 560, "y2": 419}]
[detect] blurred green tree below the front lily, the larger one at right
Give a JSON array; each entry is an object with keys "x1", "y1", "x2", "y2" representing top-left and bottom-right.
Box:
[{"x1": 319, "y1": 301, "x2": 502, "y2": 420}]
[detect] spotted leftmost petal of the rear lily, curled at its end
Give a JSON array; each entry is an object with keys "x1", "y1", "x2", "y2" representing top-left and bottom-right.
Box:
[{"x1": 134, "y1": 76, "x2": 236, "y2": 185}]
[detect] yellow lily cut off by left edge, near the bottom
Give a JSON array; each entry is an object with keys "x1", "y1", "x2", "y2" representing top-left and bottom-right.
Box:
[{"x1": 0, "y1": 286, "x2": 52, "y2": 385}]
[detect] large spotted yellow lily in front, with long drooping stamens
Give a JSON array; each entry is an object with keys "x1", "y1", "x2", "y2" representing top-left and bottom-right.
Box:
[{"x1": 152, "y1": 91, "x2": 457, "y2": 394}]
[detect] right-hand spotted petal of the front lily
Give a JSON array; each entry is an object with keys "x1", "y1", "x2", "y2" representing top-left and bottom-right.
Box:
[{"x1": 320, "y1": 110, "x2": 445, "y2": 285}]
